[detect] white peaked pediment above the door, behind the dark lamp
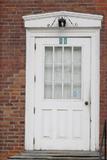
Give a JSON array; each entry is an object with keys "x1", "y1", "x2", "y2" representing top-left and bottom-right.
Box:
[{"x1": 23, "y1": 11, "x2": 103, "y2": 29}]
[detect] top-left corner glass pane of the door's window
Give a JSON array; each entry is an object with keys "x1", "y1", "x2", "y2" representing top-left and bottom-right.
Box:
[{"x1": 45, "y1": 47, "x2": 53, "y2": 64}]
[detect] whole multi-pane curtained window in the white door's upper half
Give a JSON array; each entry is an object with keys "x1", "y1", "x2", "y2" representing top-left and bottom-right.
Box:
[{"x1": 44, "y1": 46, "x2": 82, "y2": 99}]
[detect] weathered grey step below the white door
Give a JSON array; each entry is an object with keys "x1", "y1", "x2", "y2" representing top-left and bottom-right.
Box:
[{"x1": 8, "y1": 151, "x2": 99, "y2": 160}]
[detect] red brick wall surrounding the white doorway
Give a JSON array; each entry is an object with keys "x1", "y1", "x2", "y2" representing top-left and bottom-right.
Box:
[{"x1": 0, "y1": 0, "x2": 107, "y2": 160}]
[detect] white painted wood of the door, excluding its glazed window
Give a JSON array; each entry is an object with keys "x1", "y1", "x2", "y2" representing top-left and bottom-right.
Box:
[{"x1": 34, "y1": 37, "x2": 90, "y2": 150}]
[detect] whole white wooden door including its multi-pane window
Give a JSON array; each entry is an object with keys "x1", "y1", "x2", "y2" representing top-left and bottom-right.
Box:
[{"x1": 34, "y1": 37, "x2": 90, "y2": 150}]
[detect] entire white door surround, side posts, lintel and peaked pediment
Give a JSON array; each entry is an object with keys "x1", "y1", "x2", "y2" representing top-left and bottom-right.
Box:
[{"x1": 24, "y1": 11, "x2": 102, "y2": 150}]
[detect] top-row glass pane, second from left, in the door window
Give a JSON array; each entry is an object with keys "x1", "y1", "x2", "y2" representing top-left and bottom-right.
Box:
[{"x1": 54, "y1": 47, "x2": 62, "y2": 64}]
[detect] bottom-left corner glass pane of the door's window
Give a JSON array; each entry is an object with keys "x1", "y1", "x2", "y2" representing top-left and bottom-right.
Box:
[{"x1": 44, "y1": 84, "x2": 52, "y2": 98}]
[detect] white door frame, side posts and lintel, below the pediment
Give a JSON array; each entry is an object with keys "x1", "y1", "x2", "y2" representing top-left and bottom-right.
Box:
[{"x1": 22, "y1": 10, "x2": 102, "y2": 151}]
